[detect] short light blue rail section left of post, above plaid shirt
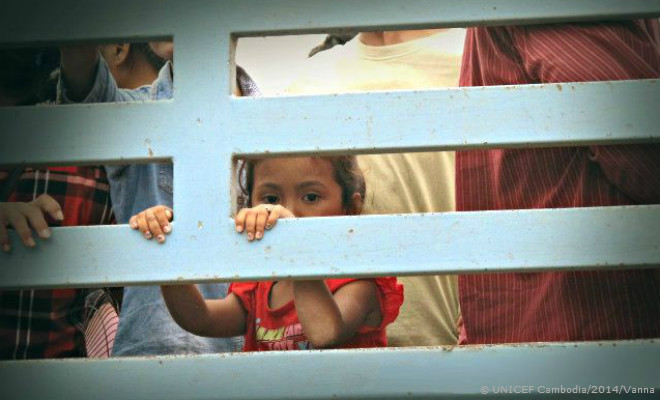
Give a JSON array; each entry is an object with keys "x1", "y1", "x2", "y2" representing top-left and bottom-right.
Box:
[{"x1": 0, "y1": 101, "x2": 177, "y2": 165}]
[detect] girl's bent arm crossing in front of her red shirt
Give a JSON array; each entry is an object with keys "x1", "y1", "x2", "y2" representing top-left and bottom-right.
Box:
[{"x1": 293, "y1": 280, "x2": 382, "y2": 348}]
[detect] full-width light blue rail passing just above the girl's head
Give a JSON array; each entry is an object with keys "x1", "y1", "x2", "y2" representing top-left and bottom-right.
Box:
[{"x1": 0, "y1": 80, "x2": 660, "y2": 164}]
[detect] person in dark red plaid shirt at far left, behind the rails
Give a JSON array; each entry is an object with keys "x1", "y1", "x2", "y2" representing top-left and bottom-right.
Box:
[{"x1": 0, "y1": 48, "x2": 114, "y2": 360}]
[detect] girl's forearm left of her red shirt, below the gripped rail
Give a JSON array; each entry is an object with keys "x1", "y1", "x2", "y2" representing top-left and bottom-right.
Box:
[{"x1": 161, "y1": 285, "x2": 246, "y2": 337}]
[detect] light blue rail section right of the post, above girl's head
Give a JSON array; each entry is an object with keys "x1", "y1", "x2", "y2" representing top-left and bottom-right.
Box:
[{"x1": 230, "y1": 80, "x2": 660, "y2": 155}]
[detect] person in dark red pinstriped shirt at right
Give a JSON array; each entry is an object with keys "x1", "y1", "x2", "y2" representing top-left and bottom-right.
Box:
[{"x1": 456, "y1": 20, "x2": 660, "y2": 344}]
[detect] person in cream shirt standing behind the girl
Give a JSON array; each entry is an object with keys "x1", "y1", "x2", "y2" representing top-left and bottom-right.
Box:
[{"x1": 287, "y1": 29, "x2": 465, "y2": 346}]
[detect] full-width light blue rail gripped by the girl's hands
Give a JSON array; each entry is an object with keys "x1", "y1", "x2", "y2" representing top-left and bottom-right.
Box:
[{"x1": 0, "y1": 205, "x2": 660, "y2": 288}]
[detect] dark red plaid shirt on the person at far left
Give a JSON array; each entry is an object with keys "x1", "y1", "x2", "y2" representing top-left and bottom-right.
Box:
[{"x1": 0, "y1": 167, "x2": 114, "y2": 359}]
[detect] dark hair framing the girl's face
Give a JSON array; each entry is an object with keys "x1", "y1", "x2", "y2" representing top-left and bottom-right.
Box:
[{"x1": 238, "y1": 156, "x2": 367, "y2": 212}]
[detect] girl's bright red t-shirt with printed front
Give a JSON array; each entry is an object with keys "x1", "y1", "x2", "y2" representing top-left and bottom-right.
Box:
[{"x1": 229, "y1": 277, "x2": 403, "y2": 351}]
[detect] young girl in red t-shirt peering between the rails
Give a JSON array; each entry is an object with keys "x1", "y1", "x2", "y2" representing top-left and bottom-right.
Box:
[{"x1": 131, "y1": 156, "x2": 403, "y2": 351}]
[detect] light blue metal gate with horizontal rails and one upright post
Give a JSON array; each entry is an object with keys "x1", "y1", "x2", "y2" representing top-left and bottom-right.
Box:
[{"x1": 0, "y1": 0, "x2": 660, "y2": 399}]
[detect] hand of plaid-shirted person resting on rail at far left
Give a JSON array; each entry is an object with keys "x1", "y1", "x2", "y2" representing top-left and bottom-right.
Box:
[{"x1": 0, "y1": 194, "x2": 64, "y2": 253}]
